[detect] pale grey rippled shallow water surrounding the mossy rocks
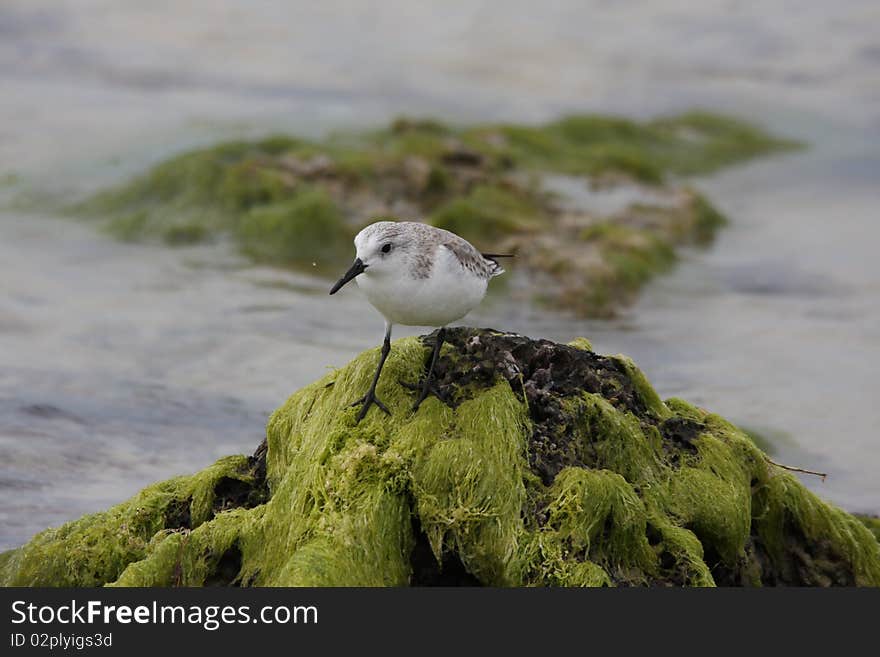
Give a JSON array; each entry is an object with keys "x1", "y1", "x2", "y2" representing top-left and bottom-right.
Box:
[{"x1": 0, "y1": 0, "x2": 880, "y2": 548}]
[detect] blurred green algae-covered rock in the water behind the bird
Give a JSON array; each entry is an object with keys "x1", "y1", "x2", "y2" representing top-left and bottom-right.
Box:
[{"x1": 75, "y1": 112, "x2": 794, "y2": 316}]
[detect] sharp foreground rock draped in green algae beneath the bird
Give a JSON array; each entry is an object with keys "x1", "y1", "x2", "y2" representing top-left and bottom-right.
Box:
[{"x1": 0, "y1": 328, "x2": 880, "y2": 586}]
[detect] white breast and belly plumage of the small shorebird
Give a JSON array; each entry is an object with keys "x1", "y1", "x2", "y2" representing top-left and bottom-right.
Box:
[{"x1": 356, "y1": 246, "x2": 489, "y2": 326}]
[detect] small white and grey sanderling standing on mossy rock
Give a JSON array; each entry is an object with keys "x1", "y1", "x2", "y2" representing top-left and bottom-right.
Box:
[{"x1": 330, "y1": 221, "x2": 510, "y2": 422}]
